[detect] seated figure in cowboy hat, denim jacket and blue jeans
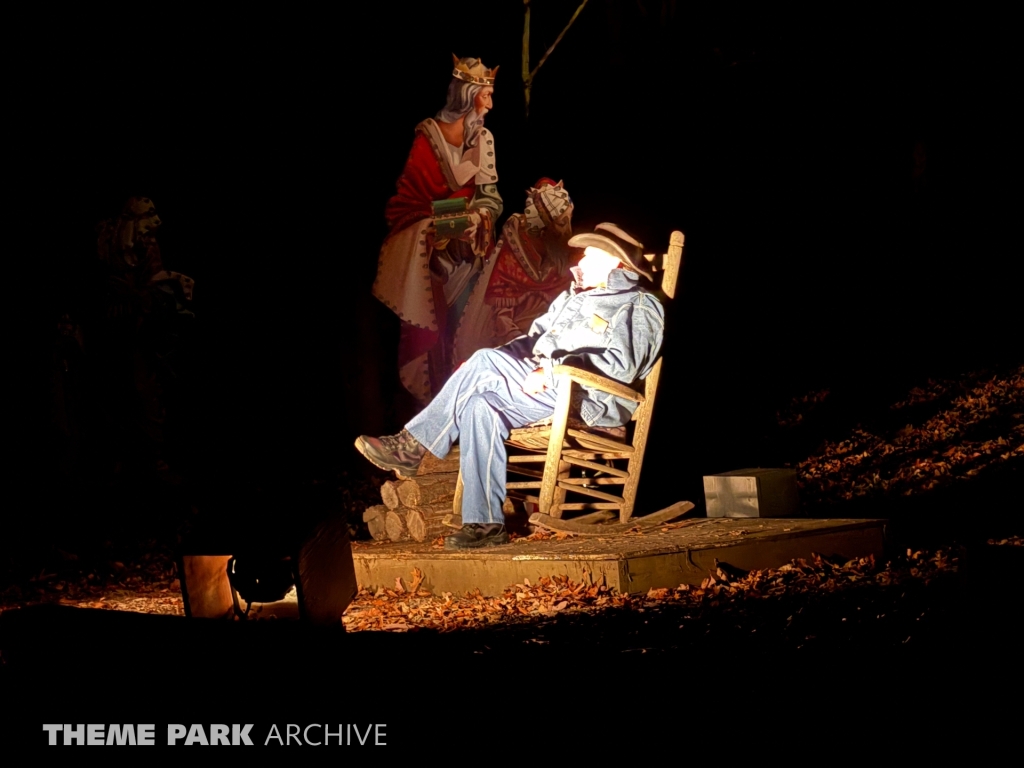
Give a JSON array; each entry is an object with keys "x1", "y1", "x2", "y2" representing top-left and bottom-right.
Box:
[{"x1": 355, "y1": 223, "x2": 665, "y2": 549}]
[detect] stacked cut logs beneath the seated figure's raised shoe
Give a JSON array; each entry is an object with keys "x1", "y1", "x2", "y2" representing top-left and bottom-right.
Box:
[{"x1": 362, "y1": 449, "x2": 459, "y2": 542}]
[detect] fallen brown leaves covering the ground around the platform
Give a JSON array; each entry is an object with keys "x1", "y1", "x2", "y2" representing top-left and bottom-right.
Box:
[{"x1": 0, "y1": 367, "x2": 1024, "y2": 653}]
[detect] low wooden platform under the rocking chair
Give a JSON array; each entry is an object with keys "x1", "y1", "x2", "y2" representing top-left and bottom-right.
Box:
[{"x1": 352, "y1": 518, "x2": 886, "y2": 595}]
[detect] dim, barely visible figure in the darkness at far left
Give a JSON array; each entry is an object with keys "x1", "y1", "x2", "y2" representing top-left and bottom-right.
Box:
[{"x1": 53, "y1": 198, "x2": 194, "y2": 481}]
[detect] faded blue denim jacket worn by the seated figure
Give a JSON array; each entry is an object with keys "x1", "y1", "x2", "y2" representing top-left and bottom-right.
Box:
[{"x1": 506, "y1": 269, "x2": 665, "y2": 427}]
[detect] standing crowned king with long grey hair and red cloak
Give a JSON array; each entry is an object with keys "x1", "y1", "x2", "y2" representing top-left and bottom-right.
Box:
[{"x1": 373, "y1": 55, "x2": 502, "y2": 403}]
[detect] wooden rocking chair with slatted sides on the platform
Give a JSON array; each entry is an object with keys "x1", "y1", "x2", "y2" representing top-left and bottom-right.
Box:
[{"x1": 453, "y1": 231, "x2": 693, "y2": 534}]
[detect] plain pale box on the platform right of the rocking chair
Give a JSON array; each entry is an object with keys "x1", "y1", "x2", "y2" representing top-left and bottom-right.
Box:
[{"x1": 703, "y1": 468, "x2": 800, "y2": 517}]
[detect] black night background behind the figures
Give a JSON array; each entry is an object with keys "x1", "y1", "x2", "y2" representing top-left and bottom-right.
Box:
[{"x1": 8, "y1": 0, "x2": 1018, "y2": 520}]
